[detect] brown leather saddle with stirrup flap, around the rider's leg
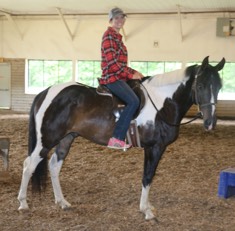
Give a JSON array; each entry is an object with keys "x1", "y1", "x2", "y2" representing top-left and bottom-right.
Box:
[{"x1": 96, "y1": 80, "x2": 145, "y2": 147}]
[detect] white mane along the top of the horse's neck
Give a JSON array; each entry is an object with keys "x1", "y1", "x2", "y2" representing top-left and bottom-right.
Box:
[{"x1": 149, "y1": 69, "x2": 190, "y2": 87}]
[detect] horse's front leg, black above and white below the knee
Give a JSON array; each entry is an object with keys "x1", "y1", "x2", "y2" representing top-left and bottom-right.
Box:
[{"x1": 140, "y1": 145, "x2": 165, "y2": 220}]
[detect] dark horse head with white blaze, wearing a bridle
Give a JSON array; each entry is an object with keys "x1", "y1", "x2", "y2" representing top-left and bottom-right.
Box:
[{"x1": 193, "y1": 56, "x2": 225, "y2": 131}]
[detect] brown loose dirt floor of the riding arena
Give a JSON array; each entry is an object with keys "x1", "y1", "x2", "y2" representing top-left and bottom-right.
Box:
[{"x1": 0, "y1": 115, "x2": 235, "y2": 231}]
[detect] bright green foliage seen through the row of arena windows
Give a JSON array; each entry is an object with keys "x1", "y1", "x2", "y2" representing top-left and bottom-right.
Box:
[{"x1": 28, "y1": 60, "x2": 235, "y2": 95}]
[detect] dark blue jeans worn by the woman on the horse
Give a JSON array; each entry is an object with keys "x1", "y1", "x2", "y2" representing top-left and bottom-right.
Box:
[{"x1": 105, "y1": 80, "x2": 140, "y2": 140}]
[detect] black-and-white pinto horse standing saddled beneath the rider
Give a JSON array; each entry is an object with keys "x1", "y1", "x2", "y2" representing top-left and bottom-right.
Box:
[{"x1": 18, "y1": 57, "x2": 225, "y2": 220}]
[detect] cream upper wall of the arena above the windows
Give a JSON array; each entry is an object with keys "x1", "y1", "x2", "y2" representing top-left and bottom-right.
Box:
[{"x1": 0, "y1": 14, "x2": 235, "y2": 61}]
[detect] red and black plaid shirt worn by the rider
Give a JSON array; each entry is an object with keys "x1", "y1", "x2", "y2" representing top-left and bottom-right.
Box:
[{"x1": 99, "y1": 27, "x2": 135, "y2": 84}]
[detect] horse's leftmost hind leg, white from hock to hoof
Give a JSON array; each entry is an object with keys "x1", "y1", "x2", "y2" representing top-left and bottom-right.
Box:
[{"x1": 18, "y1": 147, "x2": 42, "y2": 210}]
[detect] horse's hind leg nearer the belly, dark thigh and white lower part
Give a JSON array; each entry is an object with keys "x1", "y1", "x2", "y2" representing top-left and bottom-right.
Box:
[{"x1": 49, "y1": 133, "x2": 76, "y2": 209}]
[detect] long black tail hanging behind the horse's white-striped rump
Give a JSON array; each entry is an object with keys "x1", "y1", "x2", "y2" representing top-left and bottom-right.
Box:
[{"x1": 28, "y1": 90, "x2": 48, "y2": 192}]
